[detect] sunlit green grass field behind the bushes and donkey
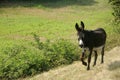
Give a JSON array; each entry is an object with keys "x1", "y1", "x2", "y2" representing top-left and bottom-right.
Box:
[{"x1": 0, "y1": 0, "x2": 120, "y2": 79}]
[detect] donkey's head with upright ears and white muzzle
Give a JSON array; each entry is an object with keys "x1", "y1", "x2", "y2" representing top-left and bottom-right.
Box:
[{"x1": 75, "y1": 21, "x2": 85, "y2": 48}]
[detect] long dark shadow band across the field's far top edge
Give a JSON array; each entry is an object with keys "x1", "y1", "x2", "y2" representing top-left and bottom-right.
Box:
[{"x1": 0, "y1": 0, "x2": 97, "y2": 8}]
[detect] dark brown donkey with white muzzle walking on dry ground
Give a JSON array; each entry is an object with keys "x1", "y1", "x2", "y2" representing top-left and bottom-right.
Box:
[{"x1": 75, "y1": 21, "x2": 107, "y2": 70}]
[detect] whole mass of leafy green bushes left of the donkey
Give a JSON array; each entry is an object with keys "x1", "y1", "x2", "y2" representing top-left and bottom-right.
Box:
[{"x1": 0, "y1": 35, "x2": 80, "y2": 80}]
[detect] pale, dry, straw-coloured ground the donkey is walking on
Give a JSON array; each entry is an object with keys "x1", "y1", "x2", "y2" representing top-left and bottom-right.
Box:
[{"x1": 24, "y1": 47, "x2": 120, "y2": 80}]
